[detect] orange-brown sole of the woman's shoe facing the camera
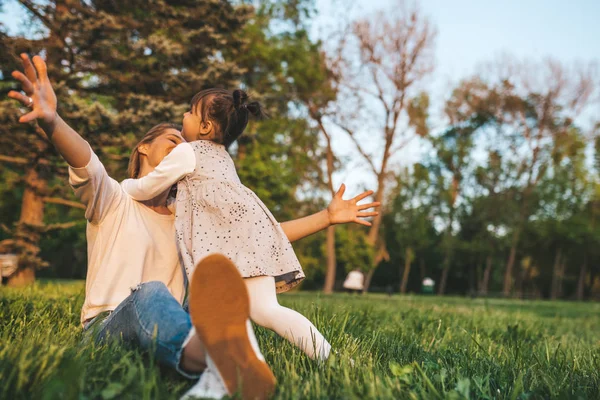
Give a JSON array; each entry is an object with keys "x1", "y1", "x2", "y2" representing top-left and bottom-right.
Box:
[{"x1": 189, "y1": 254, "x2": 275, "y2": 400}]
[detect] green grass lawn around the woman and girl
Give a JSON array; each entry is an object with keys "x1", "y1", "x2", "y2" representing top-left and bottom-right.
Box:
[{"x1": 0, "y1": 282, "x2": 600, "y2": 399}]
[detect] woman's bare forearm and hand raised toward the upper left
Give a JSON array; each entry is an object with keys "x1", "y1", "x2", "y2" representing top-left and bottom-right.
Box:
[{"x1": 8, "y1": 54, "x2": 91, "y2": 168}]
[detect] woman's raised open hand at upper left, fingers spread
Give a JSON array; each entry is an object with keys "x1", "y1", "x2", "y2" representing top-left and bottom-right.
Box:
[{"x1": 8, "y1": 53, "x2": 56, "y2": 126}]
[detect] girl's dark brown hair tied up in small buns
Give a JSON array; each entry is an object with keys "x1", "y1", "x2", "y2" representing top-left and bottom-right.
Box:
[{"x1": 191, "y1": 88, "x2": 265, "y2": 147}]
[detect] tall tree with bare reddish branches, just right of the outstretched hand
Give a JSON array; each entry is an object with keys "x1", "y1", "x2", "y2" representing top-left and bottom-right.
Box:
[{"x1": 336, "y1": 3, "x2": 435, "y2": 291}]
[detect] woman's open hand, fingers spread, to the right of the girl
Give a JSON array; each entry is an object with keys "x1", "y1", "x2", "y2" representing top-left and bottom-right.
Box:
[{"x1": 327, "y1": 184, "x2": 381, "y2": 226}]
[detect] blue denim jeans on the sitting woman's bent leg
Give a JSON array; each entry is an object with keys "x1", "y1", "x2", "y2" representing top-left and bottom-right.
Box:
[{"x1": 84, "y1": 282, "x2": 200, "y2": 379}]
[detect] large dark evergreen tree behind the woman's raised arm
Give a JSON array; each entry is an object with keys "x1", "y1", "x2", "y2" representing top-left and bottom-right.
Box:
[{"x1": 0, "y1": 0, "x2": 262, "y2": 283}]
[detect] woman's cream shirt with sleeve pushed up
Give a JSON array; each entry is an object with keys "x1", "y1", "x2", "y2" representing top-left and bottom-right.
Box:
[{"x1": 69, "y1": 144, "x2": 185, "y2": 324}]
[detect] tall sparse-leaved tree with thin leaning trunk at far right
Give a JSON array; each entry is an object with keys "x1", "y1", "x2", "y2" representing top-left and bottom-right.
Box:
[{"x1": 452, "y1": 59, "x2": 595, "y2": 295}]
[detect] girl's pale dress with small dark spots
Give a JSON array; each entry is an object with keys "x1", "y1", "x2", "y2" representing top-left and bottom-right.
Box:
[{"x1": 175, "y1": 140, "x2": 304, "y2": 293}]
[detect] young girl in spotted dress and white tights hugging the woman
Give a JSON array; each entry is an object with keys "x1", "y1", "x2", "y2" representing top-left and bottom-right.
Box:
[{"x1": 123, "y1": 89, "x2": 376, "y2": 360}]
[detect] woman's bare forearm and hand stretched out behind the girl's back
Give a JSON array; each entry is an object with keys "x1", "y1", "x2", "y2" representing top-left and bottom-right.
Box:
[{"x1": 281, "y1": 184, "x2": 380, "y2": 242}]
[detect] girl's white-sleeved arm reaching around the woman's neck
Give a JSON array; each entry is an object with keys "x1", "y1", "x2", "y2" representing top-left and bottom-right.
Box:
[{"x1": 122, "y1": 143, "x2": 196, "y2": 201}]
